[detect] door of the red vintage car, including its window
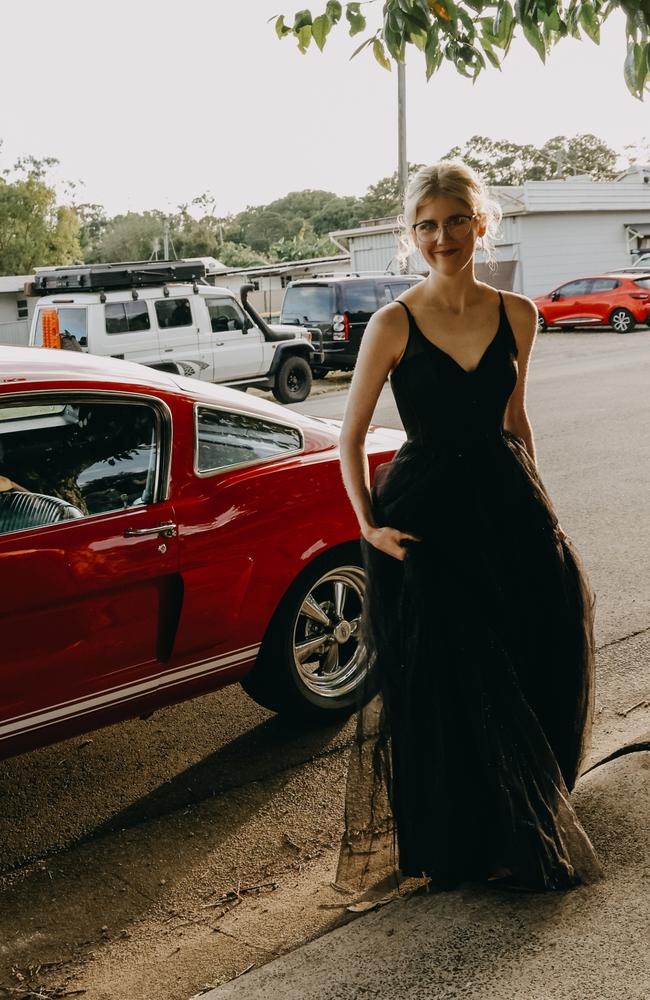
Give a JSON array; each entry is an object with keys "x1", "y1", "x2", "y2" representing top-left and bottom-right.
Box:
[{"x1": 0, "y1": 394, "x2": 180, "y2": 747}]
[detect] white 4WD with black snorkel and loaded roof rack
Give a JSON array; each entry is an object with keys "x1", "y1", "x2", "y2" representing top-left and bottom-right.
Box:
[{"x1": 29, "y1": 260, "x2": 322, "y2": 403}]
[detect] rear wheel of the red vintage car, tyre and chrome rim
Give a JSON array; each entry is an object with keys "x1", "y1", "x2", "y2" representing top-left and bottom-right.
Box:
[{"x1": 241, "y1": 546, "x2": 375, "y2": 725}]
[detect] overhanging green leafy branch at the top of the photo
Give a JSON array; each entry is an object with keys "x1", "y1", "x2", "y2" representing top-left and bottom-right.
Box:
[{"x1": 269, "y1": 0, "x2": 650, "y2": 100}]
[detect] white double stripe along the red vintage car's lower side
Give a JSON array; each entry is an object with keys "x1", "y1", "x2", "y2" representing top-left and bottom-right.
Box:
[{"x1": 0, "y1": 645, "x2": 260, "y2": 741}]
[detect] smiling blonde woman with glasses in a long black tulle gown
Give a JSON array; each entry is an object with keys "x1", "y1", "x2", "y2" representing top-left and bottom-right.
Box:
[{"x1": 337, "y1": 161, "x2": 600, "y2": 889}]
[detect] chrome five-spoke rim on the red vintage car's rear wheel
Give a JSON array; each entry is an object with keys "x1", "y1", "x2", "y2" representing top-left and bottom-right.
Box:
[{"x1": 292, "y1": 566, "x2": 366, "y2": 698}]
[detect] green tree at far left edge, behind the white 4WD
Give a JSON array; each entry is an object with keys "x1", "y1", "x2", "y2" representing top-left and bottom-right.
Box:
[{"x1": 0, "y1": 150, "x2": 81, "y2": 274}]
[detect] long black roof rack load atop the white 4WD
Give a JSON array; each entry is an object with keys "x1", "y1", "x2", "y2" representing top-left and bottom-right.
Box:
[{"x1": 32, "y1": 260, "x2": 205, "y2": 295}]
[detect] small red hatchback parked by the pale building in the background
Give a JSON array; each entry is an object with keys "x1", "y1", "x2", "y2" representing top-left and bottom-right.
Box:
[{"x1": 533, "y1": 272, "x2": 650, "y2": 333}]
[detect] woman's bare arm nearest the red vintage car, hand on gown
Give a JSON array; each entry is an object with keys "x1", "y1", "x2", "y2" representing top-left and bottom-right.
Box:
[{"x1": 339, "y1": 303, "x2": 418, "y2": 559}]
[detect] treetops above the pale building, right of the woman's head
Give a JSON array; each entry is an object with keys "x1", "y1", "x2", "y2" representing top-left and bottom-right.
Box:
[{"x1": 442, "y1": 135, "x2": 617, "y2": 186}]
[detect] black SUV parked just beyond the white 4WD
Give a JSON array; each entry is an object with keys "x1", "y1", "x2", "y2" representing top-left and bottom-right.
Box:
[{"x1": 280, "y1": 274, "x2": 422, "y2": 377}]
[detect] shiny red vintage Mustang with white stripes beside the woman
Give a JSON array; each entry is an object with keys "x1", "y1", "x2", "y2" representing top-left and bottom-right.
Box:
[{"x1": 0, "y1": 347, "x2": 403, "y2": 756}]
